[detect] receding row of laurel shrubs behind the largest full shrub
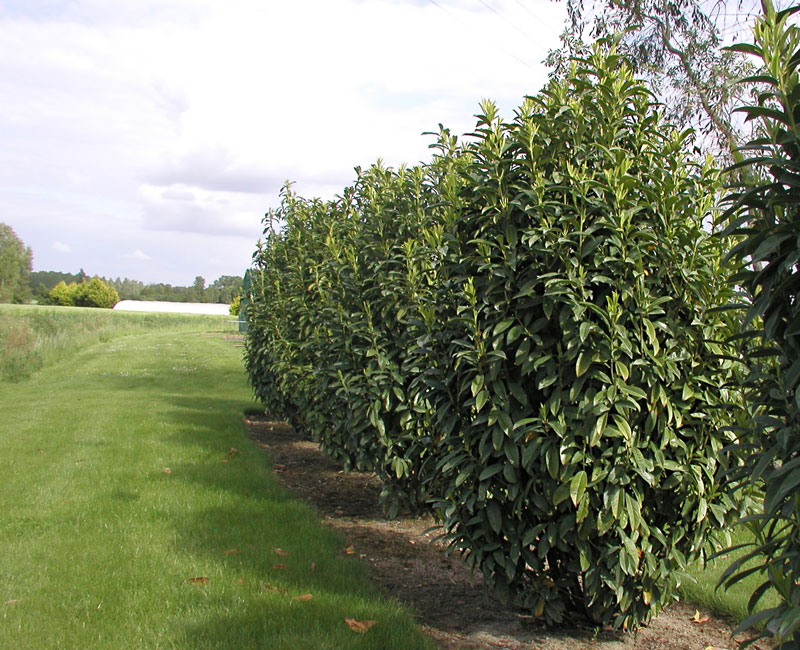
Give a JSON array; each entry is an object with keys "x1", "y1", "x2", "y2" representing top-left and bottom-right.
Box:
[{"x1": 247, "y1": 144, "x2": 462, "y2": 515}]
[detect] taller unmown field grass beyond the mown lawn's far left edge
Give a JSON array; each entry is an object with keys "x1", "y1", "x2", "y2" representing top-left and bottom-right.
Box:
[{"x1": 0, "y1": 305, "x2": 233, "y2": 382}]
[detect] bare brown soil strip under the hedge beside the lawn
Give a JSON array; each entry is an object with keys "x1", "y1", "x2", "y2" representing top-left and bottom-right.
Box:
[{"x1": 245, "y1": 415, "x2": 772, "y2": 650}]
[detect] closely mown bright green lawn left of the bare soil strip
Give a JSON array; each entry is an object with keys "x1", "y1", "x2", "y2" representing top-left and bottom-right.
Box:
[{"x1": 0, "y1": 331, "x2": 429, "y2": 650}]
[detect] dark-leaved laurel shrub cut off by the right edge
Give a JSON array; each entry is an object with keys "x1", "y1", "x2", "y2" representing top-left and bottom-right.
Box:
[{"x1": 722, "y1": 1, "x2": 800, "y2": 650}]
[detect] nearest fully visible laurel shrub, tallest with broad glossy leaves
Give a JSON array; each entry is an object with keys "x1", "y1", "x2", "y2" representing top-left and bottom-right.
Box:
[{"x1": 428, "y1": 46, "x2": 748, "y2": 629}]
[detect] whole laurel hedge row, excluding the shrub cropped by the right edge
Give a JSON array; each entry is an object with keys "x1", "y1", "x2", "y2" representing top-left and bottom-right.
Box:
[{"x1": 246, "y1": 44, "x2": 740, "y2": 629}]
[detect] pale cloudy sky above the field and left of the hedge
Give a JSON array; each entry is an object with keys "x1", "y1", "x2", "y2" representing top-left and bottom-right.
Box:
[{"x1": 0, "y1": 0, "x2": 565, "y2": 286}]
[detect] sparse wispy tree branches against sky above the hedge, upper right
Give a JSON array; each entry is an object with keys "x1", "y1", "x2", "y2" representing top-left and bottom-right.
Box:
[{"x1": 555, "y1": 0, "x2": 751, "y2": 160}]
